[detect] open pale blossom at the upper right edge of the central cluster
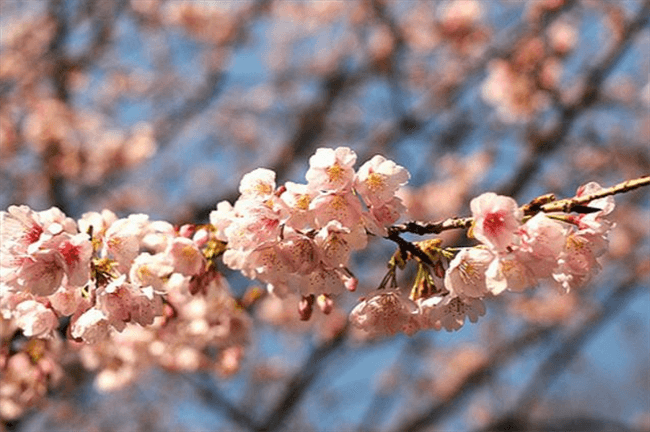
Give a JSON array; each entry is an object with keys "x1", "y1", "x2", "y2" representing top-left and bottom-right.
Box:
[{"x1": 354, "y1": 155, "x2": 410, "y2": 205}]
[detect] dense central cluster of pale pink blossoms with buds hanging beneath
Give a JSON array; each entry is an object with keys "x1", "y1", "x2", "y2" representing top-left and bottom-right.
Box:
[{"x1": 210, "y1": 147, "x2": 409, "y2": 319}]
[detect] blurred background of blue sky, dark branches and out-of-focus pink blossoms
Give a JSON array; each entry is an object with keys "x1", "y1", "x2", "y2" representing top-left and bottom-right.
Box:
[{"x1": 0, "y1": 0, "x2": 650, "y2": 431}]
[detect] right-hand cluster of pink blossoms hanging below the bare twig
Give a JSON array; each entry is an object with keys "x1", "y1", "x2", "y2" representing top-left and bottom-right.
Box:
[{"x1": 350, "y1": 182, "x2": 614, "y2": 334}]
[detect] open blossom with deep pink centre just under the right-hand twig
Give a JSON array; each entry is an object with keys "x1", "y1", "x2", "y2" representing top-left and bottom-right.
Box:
[{"x1": 470, "y1": 192, "x2": 523, "y2": 252}]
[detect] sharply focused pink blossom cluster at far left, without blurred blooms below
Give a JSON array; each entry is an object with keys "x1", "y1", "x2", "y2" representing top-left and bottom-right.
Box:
[{"x1": 0, "y1": 206, "x2": 248, "y2": 343}]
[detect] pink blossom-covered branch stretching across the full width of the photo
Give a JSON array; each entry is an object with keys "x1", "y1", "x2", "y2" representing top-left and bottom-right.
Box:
[{"x1": 0, "y1": 147, "x2": 650, "y2": 422}]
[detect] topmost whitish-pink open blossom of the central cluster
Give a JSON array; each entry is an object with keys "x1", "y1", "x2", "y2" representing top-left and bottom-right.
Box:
[{"x1": 305, "y1": 147, "x2": 357, "y2": 192}]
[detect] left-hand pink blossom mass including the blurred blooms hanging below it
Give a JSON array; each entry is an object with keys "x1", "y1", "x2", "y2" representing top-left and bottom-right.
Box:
[{"x1": 0, "y1": 206, "x2": 251, "y2": 419}]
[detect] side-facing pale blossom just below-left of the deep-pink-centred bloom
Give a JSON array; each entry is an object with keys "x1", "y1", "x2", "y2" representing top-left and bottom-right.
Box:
[{"x1": 445, "y1": 248, "x2": 494, "y2": 299}]
